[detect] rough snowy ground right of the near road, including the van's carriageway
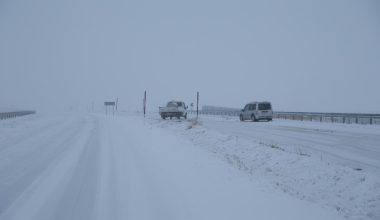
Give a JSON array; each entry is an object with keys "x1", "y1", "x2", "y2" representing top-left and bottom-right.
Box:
[{"x1": 142, "y1": 112, "x2": 380, "y2": 219}]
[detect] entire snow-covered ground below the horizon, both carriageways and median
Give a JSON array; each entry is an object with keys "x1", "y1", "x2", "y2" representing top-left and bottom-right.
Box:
[{"x1": 0, "y1": 113, "x2": 380, "y2": 220}]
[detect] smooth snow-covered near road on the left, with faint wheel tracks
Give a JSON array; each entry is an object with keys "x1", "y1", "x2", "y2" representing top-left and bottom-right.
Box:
[{"x1": 0, "y1": 114, "x2": 340, "y2": 220}]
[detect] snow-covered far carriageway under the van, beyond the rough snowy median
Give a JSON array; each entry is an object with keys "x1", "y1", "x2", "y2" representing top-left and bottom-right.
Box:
[{"x1": 196, "y1": 117, "x2": 380, "y2": 172}]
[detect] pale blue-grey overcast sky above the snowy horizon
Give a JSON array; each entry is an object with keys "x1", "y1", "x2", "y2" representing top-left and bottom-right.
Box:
[{"x1": 0, "y1": 0, "x2": 380, "y2": 112}]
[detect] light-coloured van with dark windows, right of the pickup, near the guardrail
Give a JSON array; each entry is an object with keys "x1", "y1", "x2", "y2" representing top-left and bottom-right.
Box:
[{"x1": 239, "y1": 102, "x2": 273, "y2": 121}]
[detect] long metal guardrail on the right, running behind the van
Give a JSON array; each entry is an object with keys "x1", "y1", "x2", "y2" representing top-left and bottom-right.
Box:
[{"x1": 189, "y1": 110, "x2": 380, "y2": 124}]
